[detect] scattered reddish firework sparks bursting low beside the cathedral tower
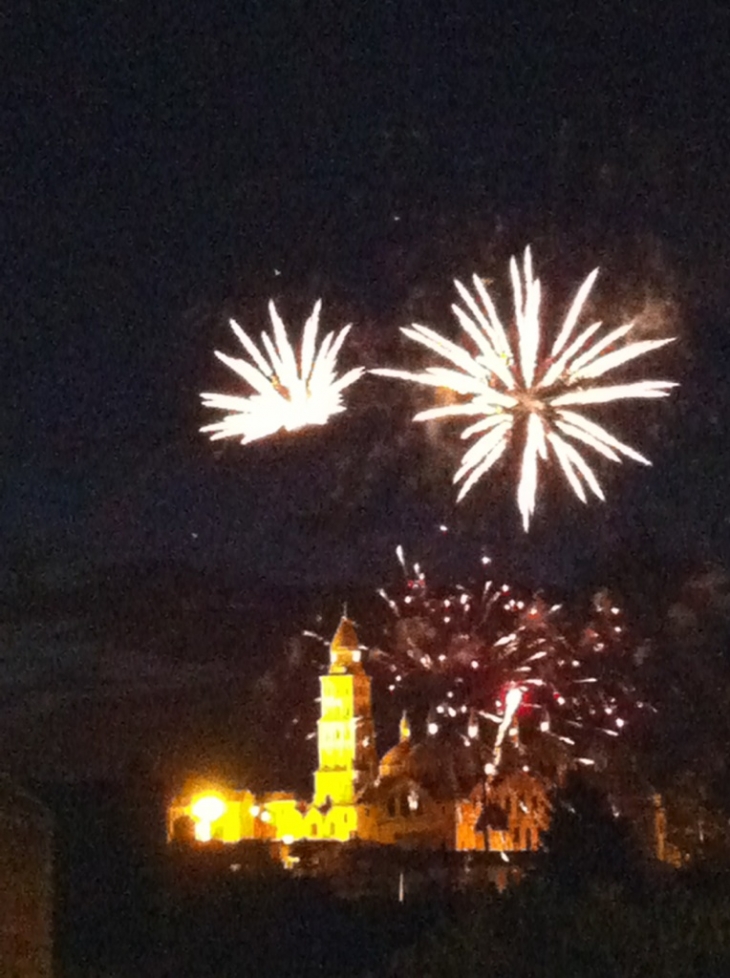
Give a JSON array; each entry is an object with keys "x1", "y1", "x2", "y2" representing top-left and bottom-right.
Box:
[{"x1": 370, "y1": 551, "x2": 641, "y2": 775}]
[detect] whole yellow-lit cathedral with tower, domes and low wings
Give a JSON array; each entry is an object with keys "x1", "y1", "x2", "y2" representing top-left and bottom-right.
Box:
[{"x1": 168, "y1": 618, "x2": 550, "y2": 853}]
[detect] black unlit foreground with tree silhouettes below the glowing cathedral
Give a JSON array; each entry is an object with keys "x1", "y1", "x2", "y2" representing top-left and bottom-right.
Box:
[{"x1": 41, "y1": 786, "x2": 730, "y2": 978}]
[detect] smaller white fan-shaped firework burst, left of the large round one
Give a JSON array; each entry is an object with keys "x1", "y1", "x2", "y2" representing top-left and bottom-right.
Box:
[{"x1": 200, "y1": 300, "x2": 364, "y2": 445}]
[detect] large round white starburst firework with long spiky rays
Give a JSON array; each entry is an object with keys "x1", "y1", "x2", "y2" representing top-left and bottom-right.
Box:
[{"x1": 374, "y1": 247, "x2": 676, "y2": 530}]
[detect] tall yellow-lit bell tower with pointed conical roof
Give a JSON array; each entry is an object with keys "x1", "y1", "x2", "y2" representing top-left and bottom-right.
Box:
[{"x1": 314, "y1": 617, "x2": 378, "y2": 806}]
